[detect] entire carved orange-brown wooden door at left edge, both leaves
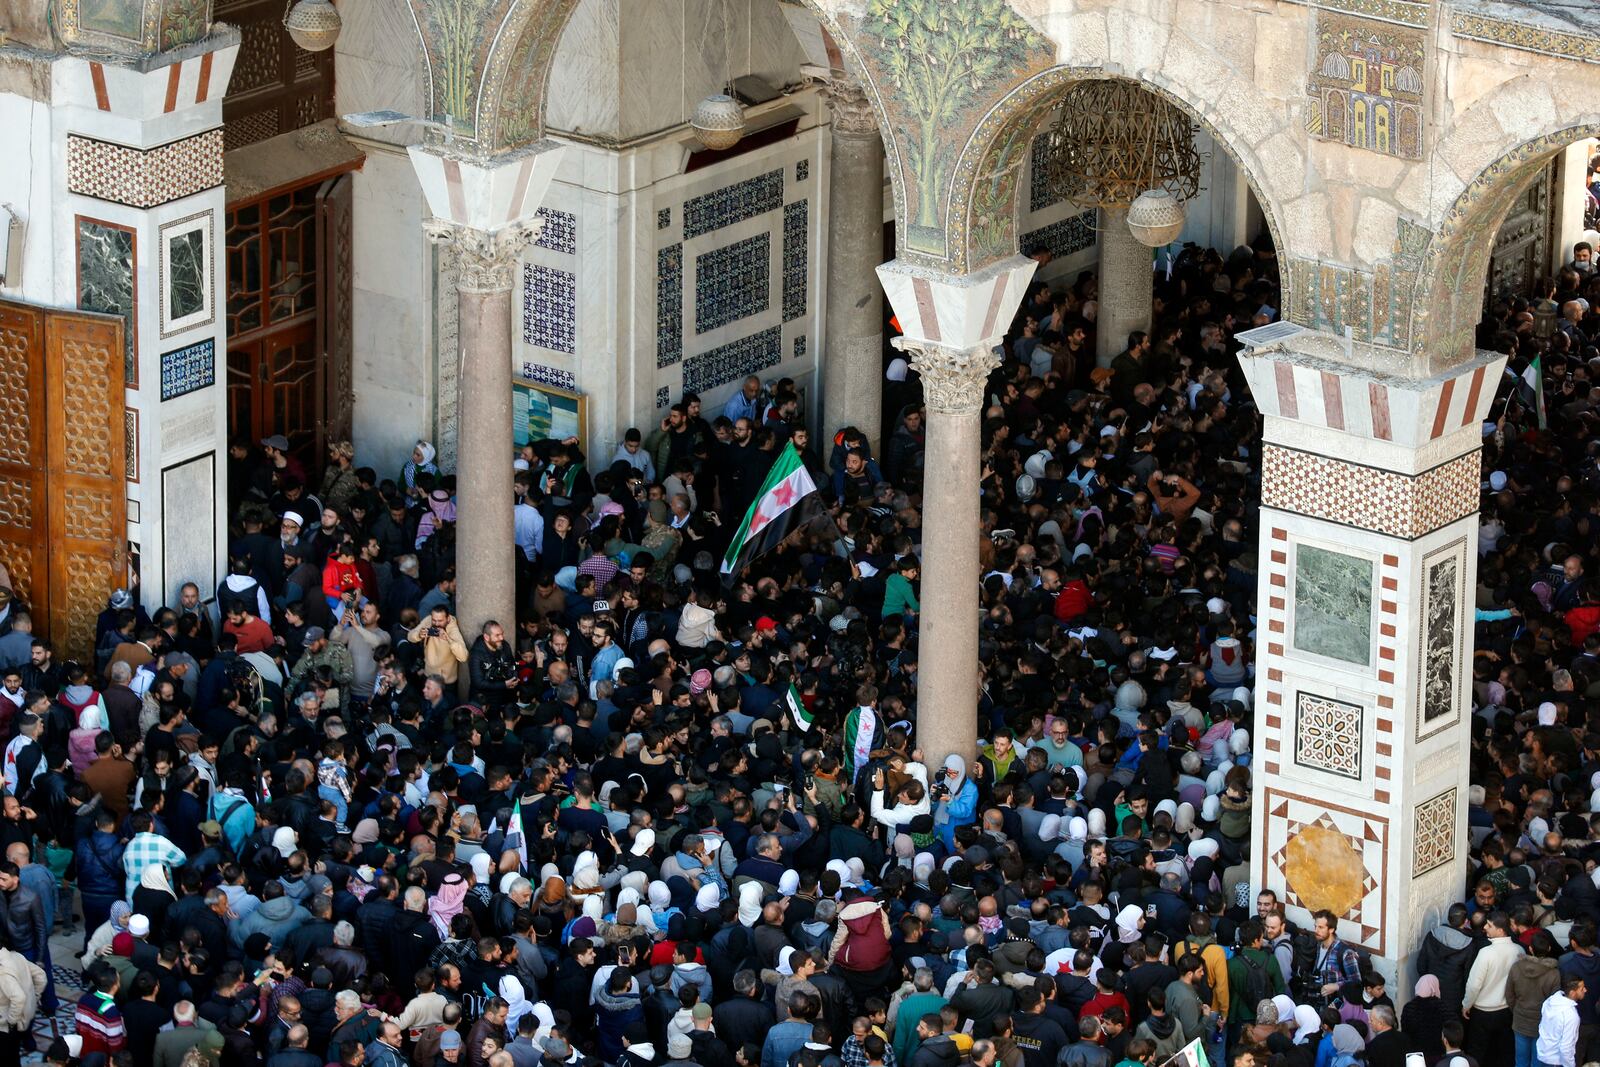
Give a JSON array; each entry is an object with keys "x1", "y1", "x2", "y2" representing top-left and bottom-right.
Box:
[{"x1": 0, "y1": 301, "x2": 128, "y2": 659}]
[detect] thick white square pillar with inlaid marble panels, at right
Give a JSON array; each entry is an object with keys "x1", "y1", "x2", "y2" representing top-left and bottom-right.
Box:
[{"x1": 1240, "y1": 340, "x2": 1506, "y2": 989}]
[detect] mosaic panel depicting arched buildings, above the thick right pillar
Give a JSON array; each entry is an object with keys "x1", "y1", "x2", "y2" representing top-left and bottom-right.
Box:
[{"x1": 1306, "y1": 10, "x2": 1426, "y2": 160}]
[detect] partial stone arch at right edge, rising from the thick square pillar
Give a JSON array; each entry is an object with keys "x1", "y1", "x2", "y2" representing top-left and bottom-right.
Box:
[{"x1": 1411, "y1": 84, "x2": 1600, "y2": 371}]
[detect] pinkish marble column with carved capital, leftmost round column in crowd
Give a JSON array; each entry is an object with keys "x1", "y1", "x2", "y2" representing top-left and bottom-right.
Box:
[{"x1": 426, "y1": 219, "x2": 542, "y2": 643}]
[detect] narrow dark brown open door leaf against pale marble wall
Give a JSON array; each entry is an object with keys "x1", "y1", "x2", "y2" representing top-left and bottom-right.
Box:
[{"x1": 317, "y1": 174, "x2": 355, "y2": 447}]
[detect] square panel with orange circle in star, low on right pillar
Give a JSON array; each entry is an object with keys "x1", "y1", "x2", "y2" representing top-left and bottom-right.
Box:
[{"x1": 1264, "y1": 787, "x2": 1389, "y2": 955}]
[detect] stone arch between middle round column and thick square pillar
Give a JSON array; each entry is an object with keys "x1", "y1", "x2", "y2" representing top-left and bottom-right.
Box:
[{"x1": 950, "y1": 64, "x2": 1288, "y2": 294}]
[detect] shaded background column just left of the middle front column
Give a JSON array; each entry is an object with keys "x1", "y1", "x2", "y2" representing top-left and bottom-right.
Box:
[{"x1": 822, "y1": 77, "x2": 883, "y2": 454}]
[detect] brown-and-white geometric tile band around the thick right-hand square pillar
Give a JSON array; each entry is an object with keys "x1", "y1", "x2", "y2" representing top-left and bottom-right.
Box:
[{"x1": 1261, "y1": 445, "x2": 1482, "y2": 541}]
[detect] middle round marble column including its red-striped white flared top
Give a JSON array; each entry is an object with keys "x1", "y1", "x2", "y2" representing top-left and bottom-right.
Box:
[{"x1": 878, "y1": 256, "x2": 1038, "y2": 766}]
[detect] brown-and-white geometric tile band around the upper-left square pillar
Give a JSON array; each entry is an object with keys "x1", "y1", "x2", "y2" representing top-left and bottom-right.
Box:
[{"x1": 67, "y1": 128, "x2": 222, "y2": 208}]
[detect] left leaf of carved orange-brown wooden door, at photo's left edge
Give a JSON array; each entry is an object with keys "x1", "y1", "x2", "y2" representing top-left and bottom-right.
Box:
[{"x1": 0, "y1": 302, "x2": 50, "y2": 627}]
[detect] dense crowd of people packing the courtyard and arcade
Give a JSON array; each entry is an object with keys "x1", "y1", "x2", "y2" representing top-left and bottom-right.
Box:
[{"x1": 0, "y1": 185, "x2": 1600, "y2": 1067}]
